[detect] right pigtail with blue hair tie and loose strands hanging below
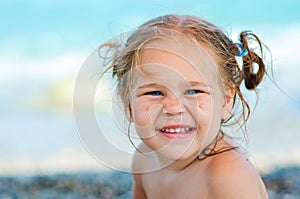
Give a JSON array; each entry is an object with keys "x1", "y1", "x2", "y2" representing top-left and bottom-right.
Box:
[{"x1": 225, "y1": 31, "x2": 266, "y2": 128}]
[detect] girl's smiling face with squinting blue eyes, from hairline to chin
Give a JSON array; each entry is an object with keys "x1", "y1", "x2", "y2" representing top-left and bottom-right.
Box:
[{"x1": 130, "y1": 38, "x2": 232, "y2": 160}]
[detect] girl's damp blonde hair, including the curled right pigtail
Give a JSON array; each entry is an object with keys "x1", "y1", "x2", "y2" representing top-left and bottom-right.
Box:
[{"x1": 100, "y1": 14, "x2": 266, "y2": 129}]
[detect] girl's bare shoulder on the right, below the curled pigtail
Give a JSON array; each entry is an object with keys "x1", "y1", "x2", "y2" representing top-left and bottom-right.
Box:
[{"x1": 208, "y1": 150, "x2": 268, "y2": 199}]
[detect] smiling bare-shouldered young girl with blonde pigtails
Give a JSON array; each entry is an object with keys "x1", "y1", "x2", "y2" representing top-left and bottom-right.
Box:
[{"x1": 102, "y1": 15, "x2": 268, "y2": 199}]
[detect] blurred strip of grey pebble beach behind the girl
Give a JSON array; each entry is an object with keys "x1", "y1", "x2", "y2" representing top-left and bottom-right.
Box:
[{"x1": 0, "y1": 167, "x2": 300, "y2": 199}]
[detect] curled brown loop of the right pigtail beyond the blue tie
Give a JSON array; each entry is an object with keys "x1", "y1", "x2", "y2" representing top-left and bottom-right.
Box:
[{"x1": 239, "y1": 31, "x2": 266, "y2": 90}]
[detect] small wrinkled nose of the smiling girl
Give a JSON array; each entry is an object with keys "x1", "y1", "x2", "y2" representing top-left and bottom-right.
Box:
[{"x1": 163, "y1": 95, "x2": 185, "y2": 116}]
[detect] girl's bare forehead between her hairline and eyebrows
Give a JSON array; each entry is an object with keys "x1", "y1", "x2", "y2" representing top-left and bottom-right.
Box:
[{"x1": 141, "y1": 37, "x2": 219, "y2": 83}]
